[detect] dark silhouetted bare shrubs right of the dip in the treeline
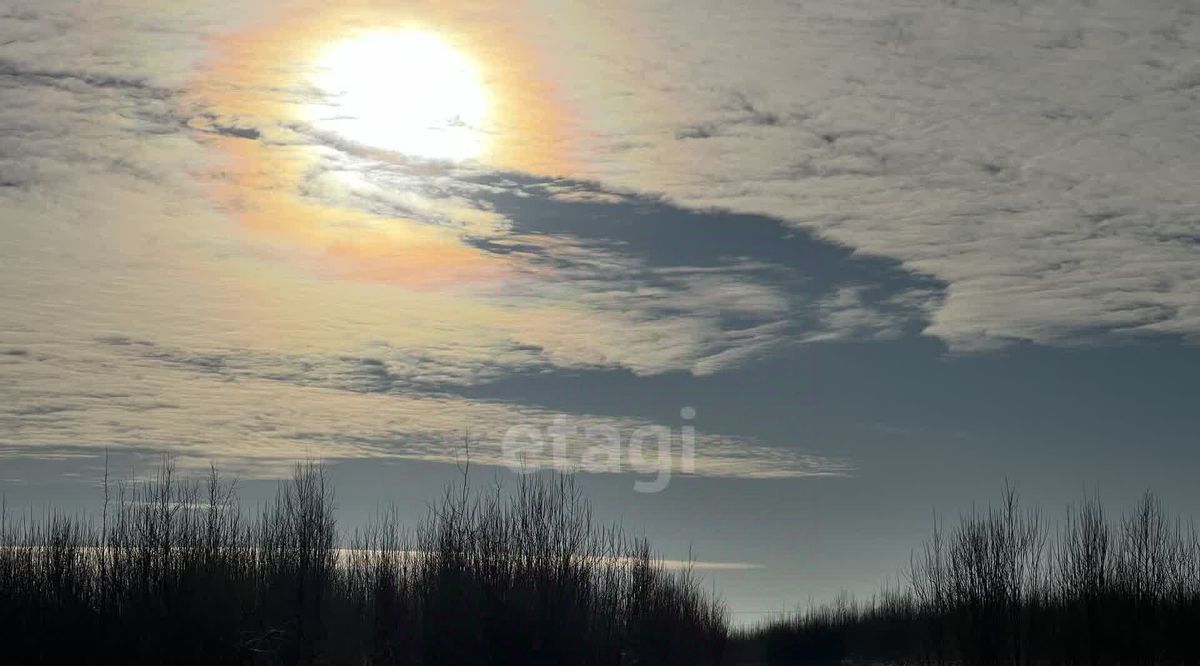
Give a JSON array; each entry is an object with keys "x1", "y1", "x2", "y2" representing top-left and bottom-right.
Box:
[{"x1": 731, "y1": 490, "x2": 1200, "y2": 666}]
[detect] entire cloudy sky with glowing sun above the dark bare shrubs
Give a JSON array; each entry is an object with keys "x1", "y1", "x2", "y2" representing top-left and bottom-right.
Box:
[{"x1": 0, "y1": 0, "x2": 1200, "y2": 619}]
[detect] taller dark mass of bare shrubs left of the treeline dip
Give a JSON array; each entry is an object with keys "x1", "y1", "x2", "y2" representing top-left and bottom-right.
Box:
[{"x1": 0, "y1": 464, "x2": 726, "y2": 665}]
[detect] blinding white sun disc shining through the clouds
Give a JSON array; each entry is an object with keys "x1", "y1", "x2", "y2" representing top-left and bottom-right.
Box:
[{"x1": 316, "y1": 30, "x2": 490, "y2": 161}]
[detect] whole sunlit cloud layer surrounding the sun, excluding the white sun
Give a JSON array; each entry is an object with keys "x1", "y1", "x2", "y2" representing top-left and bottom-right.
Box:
[{"x1": 0, "y1": 0, "x2": 1200, "y2": 484}]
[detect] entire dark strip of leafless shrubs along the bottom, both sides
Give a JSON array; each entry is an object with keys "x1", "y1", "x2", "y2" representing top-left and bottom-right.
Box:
[{"x1": 0, "y1": 464, "x2": 1200, "y2": 666}]
